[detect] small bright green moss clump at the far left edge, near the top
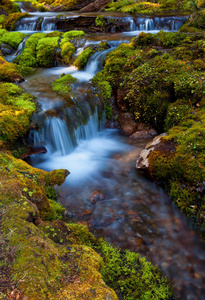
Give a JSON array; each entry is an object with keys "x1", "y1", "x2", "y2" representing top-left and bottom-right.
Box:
[{"x1": 0, "y1": 29, "x2": 26, "y2": 49}]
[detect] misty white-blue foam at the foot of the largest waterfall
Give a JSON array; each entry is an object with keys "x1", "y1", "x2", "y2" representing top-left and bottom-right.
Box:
[{"x1": 36, "y1": 129, "x2": 130, "y2": 186}]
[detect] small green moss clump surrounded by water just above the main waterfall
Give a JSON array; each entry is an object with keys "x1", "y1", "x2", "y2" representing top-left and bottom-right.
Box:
[{"x1": 51, "y1": 74, "x2": 76, "y2": 95}]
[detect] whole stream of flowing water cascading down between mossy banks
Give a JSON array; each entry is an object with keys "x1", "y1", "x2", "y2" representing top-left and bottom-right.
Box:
[{"x1": 14, "y1": 3, "x2": 205, "y2": 300}]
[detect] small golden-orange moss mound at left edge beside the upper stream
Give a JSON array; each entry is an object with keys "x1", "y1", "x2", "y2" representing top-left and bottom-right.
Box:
[{"x1": 0, "y1": 57, "x2": 23, "y2": 82}]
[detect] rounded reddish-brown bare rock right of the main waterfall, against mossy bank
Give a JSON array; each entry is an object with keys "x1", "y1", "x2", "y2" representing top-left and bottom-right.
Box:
[{"x1": 118, "y1": 113, "x2": 137, "y2": 135}]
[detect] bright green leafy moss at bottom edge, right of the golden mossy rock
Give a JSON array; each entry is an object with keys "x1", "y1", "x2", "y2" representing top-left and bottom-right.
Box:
[{"x1": 98, "y1": 240, "x2": 173, "y2": 300}]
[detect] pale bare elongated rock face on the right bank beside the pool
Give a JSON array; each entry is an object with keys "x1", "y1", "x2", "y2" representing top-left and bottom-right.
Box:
[{"x1": 136, "y1": 133, "x2": 167, "y2": 170}]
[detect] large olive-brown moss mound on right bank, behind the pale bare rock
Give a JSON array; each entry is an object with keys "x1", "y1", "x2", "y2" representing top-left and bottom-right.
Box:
[{"x1": 149, "y1": 108, "x2": 205, "y2": 230}]
